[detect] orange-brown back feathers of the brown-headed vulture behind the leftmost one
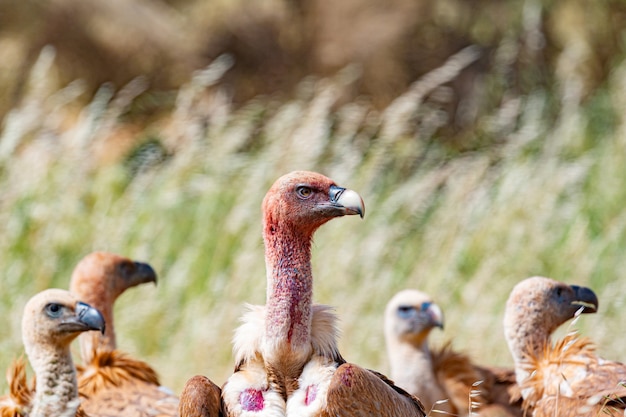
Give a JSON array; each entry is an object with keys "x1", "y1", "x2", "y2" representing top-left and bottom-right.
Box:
[{"x1": 78, "y1": 349, "x2": 178, "y2": 417}]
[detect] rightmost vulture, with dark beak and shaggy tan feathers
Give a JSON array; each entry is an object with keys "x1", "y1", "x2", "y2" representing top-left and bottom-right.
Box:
[{"x1": 504, "y1": 277, "x2": 626, "y2": 417}]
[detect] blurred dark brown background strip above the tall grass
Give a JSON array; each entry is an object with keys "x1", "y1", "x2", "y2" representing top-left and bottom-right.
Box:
[{"x1": 0, "y1": 0, "x2": 626, "y2": 147}]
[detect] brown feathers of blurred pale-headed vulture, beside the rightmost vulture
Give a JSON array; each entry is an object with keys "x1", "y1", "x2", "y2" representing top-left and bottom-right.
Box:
[{"x1": 431, "y1": 342, "x2": 523, "y2": 417}]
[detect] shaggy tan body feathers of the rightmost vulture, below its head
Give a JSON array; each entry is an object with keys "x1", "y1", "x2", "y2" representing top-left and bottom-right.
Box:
[{"x1": 521, "y1": 333, "x2": 626, "y2": 417}]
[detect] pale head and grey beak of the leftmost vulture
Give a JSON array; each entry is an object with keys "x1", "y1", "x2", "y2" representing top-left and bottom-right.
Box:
[{"x1": 22, "y1": 289, "x2": 105, "y2": 354}]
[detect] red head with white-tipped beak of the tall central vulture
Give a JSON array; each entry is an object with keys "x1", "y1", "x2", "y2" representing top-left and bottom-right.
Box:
[{"x1": 263, "y1": 171, "x2": 365, "y2": 236}]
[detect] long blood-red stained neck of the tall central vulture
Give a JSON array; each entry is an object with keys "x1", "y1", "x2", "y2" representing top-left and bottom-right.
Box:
[{"x1": 262, "y1": 225, "x2": 313, "y2": 371}]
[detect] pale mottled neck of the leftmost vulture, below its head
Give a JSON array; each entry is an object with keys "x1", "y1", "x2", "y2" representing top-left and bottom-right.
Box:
[{"x1": 27, "y1": 347, "x2": 79, "y2": 417}]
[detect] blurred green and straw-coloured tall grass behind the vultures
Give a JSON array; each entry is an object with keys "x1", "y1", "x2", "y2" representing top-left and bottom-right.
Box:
[{"x1": 0, "y1": 45, "x2": 626, "y2": 391}]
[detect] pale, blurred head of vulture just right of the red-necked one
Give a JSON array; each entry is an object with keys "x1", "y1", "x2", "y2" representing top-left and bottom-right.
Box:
[{"x1": 385, "y1": 289, "x2": 443, "y2": 347}]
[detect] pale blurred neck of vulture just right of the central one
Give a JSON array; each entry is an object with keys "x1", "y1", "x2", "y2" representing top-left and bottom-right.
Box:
[{"x1": 387, "y1": 340, "x2": 452, "y2": 412}]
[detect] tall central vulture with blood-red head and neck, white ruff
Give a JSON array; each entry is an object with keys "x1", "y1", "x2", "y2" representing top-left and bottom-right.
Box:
[{"x1": 222, "y1": 171, "x2": 426, "y2": 417}]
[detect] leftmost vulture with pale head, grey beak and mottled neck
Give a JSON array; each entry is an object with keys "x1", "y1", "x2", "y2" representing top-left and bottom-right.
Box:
[{"x1": 7, "y1": 289, "x2": 105, "y2": 417}]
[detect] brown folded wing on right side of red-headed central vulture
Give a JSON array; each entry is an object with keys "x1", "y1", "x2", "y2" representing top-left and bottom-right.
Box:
[{"x1": 319, "y1": 363, "x2": 426, "y2": 417}]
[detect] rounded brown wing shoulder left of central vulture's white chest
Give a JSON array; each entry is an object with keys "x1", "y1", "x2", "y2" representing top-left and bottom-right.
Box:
[{"x1": 178, "y1": 375, "x2": 222, "y2": 417}]
